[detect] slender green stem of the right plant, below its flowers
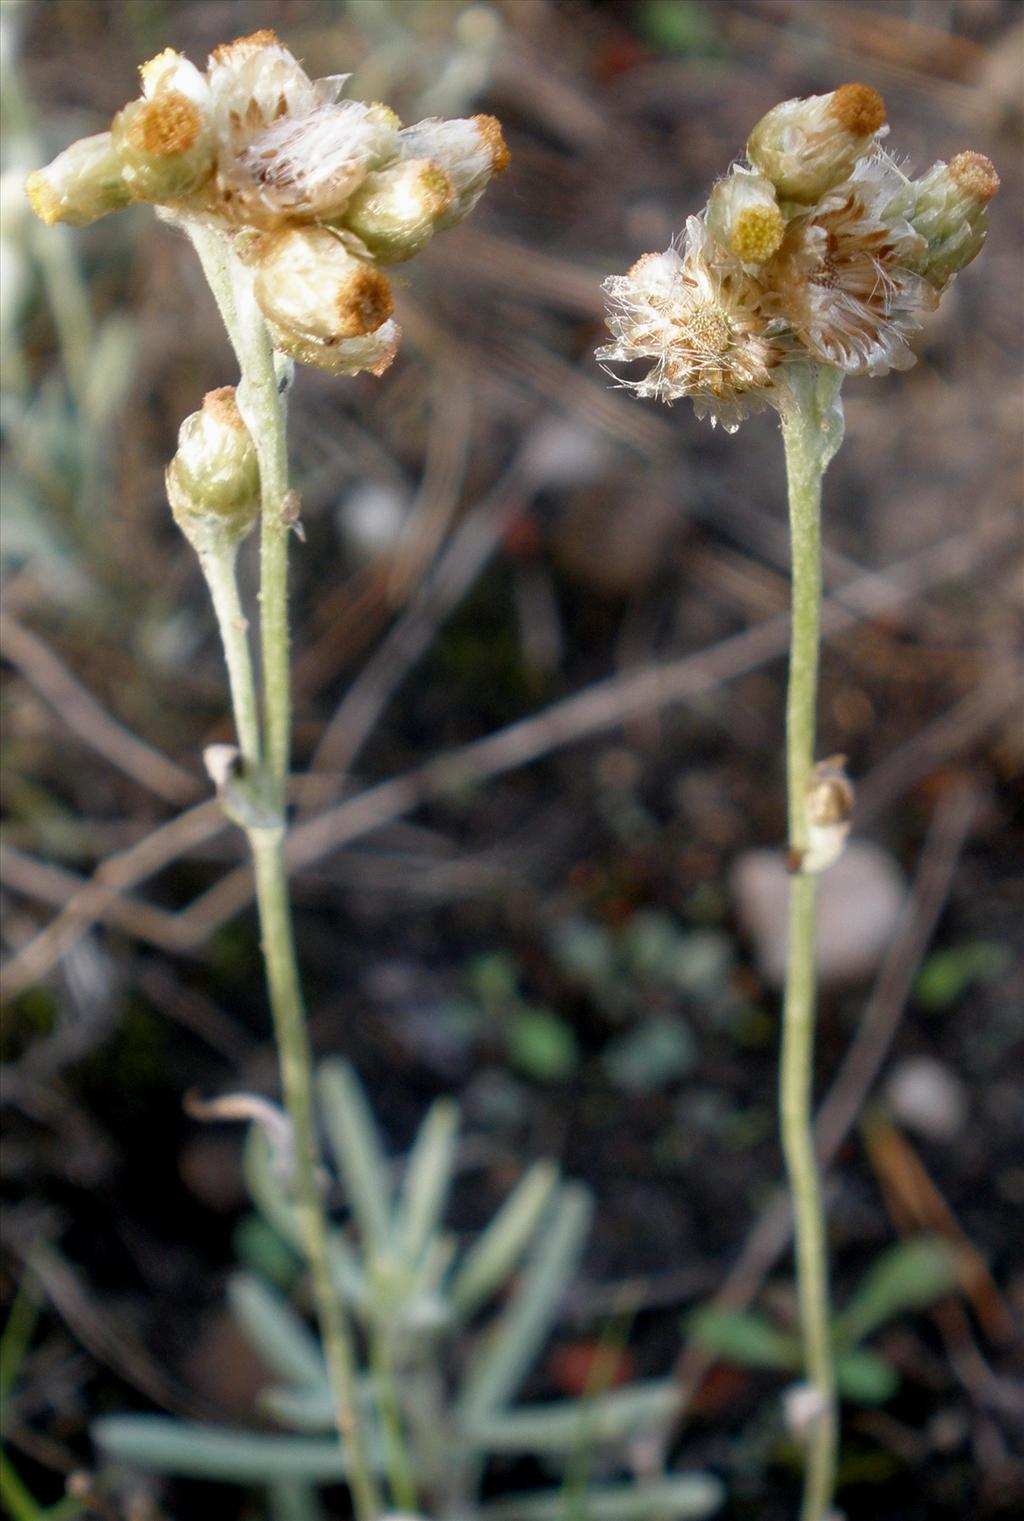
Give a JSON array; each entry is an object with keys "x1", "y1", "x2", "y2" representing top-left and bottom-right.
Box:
[{"x1": 779, "y1": 367, "x2": 841, "y2": 1521}]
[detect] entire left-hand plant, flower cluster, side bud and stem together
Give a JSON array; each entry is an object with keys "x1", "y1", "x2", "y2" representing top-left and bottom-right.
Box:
[{"x1": 26, "y1": 30, "x2": 508, "y2": 1521}]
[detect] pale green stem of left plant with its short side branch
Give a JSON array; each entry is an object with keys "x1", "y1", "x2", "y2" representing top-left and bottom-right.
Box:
[{"x1": 190, "y1": 228, "x2": 380, "y2": 1521}]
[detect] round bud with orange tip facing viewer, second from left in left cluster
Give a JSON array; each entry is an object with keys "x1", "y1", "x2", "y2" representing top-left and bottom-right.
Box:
[{"x1": 111, "y1": 88, "x2": 216, "y2": 201}]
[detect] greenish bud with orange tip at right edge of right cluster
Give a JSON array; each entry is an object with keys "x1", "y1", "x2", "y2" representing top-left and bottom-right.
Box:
[{"x1": 886, "y1": 152, "x2": 1000, "y2": 291}]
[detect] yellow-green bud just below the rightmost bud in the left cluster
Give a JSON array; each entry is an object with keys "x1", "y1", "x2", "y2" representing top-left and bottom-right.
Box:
[{"x1": 334, "y1": 158, "x2": 455, "y2": 265}]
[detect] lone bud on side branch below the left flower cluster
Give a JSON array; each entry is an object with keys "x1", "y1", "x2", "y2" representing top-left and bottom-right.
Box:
[{"x1": 167, "y1": 386, "x2": 260, "y2": 548}]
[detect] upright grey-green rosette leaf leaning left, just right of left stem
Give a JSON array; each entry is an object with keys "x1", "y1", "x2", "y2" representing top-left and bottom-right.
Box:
[{"x1": 320, "y1": 1060, "x2": 391, "y2": 1255}]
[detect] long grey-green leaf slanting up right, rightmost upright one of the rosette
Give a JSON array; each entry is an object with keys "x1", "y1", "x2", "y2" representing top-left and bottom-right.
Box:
[{"x1": 458, "y1": 1183, "x2": 593, "y2": 1422}]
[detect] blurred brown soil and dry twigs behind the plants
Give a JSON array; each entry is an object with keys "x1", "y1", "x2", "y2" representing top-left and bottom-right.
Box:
[{"x1": 0, "y1": 0, "x2": 1024, "y2": 1521}]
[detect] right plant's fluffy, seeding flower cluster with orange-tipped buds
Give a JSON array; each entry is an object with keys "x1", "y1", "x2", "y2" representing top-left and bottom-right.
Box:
[{"x1": 598, "y1": 84, "x2": 1000, "y2": 432}]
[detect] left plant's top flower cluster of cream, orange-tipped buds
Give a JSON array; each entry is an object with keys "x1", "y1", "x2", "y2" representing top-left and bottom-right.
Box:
[{"x1": 26, "y1": 32, "x2": 508, "y2": 374}]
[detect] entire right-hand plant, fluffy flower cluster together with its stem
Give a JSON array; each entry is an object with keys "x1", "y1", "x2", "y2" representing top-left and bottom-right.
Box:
[{"x1": 598, "y1": 84, "x2": 1000, "y2": 1521}]
